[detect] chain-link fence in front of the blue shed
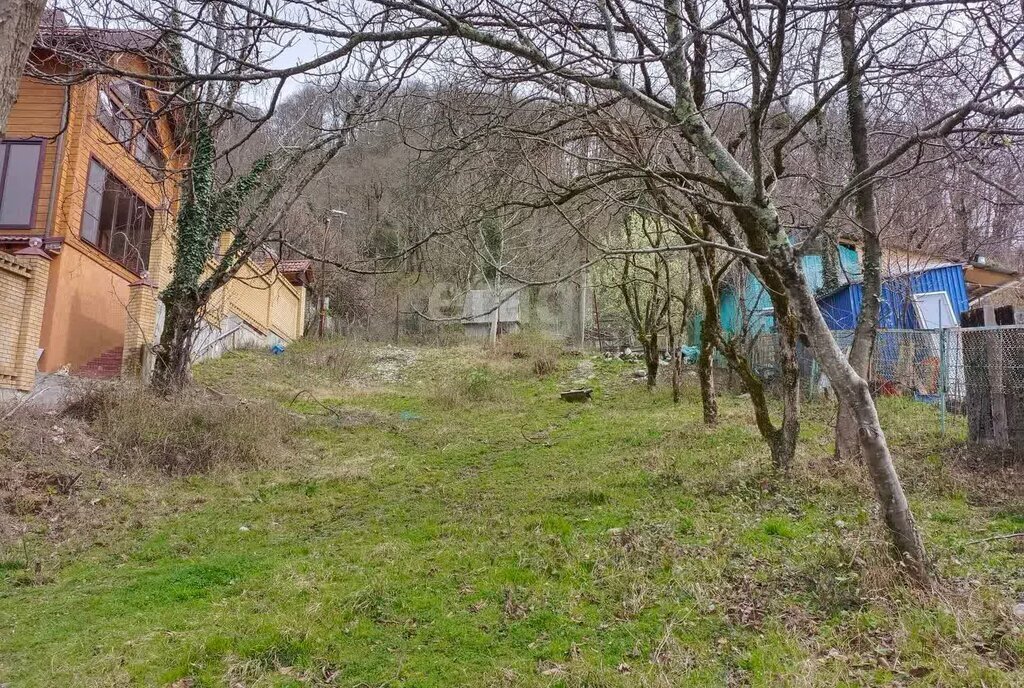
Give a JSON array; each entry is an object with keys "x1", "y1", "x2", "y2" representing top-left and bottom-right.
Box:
[{"x1": 749, "y1": 326, "x2": 1024, "y2": 446}]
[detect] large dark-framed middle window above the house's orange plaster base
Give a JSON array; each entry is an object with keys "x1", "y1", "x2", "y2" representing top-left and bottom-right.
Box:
[{"x1": 82, "y1": 160, "x2": 153, "y2": 274}]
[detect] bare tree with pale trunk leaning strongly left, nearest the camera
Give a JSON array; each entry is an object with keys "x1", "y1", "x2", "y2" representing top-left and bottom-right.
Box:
[{"x1": 321, "y1": 2, "x2": 1024, "y2": 581}]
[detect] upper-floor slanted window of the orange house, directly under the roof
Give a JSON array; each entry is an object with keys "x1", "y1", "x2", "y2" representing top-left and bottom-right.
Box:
[{"x1": 96, "y1": 81, "x2": 167, "y2": 172}]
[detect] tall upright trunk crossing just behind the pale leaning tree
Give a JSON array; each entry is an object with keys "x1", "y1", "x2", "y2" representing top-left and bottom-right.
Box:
[{"x1": 836, "y1": 1, "x2": 882, "y2": 461}]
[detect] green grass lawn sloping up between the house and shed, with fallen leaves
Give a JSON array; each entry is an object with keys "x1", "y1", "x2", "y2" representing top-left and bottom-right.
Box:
[{"x1": 0, "y1": 345, "x2": 1024, "y2": 688}]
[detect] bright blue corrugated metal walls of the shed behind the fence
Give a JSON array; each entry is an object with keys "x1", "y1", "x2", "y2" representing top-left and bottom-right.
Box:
[{"x1": 818, "y1": 263, "x2": 968, "y2": 330}]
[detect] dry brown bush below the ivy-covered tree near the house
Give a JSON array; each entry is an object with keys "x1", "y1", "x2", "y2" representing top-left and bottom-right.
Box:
[{"x1": 68, "y1": 386, "x2": 292, "y2": 474}]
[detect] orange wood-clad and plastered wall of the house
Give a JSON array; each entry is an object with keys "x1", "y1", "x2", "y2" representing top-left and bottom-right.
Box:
[{"x1": 8, "y1": 58, "x2": 177, "y2": 372}]
